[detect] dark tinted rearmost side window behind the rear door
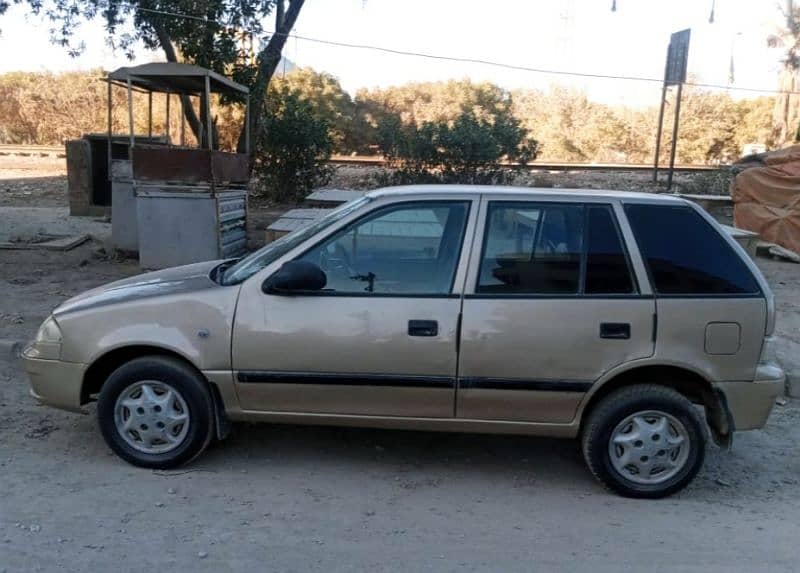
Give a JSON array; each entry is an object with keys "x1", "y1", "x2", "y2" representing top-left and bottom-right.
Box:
[{"x1": 625, "y1": 205, "x2": 760, "y2": 295}]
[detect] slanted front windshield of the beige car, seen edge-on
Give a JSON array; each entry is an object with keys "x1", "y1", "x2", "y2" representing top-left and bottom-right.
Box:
[{"x1": 222, "y1": 197, "x2": 372, "y2": 285}]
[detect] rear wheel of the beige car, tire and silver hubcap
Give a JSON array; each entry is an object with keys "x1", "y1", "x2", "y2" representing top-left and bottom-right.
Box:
[{"x1": 581, "y1": 384, "x2": 707, "y2": 499}]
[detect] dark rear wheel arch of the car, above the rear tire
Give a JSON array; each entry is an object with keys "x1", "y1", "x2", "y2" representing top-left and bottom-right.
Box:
[{"x1": 578, "y1": 363, "x2": 733, "y2": 447}]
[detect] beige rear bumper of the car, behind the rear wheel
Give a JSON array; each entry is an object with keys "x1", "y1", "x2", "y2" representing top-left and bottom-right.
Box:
[{"x1": 715, "y1": 364, "x2": 786, "y2": 431}]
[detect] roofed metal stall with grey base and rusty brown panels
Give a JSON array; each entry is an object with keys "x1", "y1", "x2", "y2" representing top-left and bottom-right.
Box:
[{"x1": 107, "y1": 62, "x2": 250, "y2": 268}]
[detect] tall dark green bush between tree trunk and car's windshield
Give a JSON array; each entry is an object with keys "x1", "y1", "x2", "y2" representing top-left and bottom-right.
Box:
[{"x1": 254, "y1": 89, "x2": 333, "y2": 202}]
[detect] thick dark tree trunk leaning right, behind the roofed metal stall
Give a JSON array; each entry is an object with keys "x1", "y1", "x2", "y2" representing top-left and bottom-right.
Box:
[{"x1": 237, "y1": 0, "x2": 305, "y2": 157}]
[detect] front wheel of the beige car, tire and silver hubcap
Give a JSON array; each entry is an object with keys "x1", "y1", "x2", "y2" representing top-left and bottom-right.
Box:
[{"x1": 97, "y1": 356, "x2": 214, "y2": 469}]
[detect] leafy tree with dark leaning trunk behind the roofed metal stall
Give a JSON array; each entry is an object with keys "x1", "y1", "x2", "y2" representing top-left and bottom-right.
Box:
[{"x1": 0, "y1": 0, "x2": 305, "y2": 156}]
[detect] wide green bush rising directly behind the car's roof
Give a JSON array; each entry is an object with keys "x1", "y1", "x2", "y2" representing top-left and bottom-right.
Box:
[{"x1": 377, "y1": 110, "x2": 539, "y2": 184}]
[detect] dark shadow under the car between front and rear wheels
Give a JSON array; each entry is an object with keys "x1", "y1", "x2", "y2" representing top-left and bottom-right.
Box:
[{"x1": 196, "y1": 423, "x2": 608, "y2": 490}]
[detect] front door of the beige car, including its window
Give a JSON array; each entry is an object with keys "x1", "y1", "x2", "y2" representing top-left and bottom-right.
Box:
[{"x1": 233, "y1": 200, "x2": 472, "y2": 417}]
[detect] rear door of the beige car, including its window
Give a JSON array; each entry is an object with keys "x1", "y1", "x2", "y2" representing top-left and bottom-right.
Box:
[{"x1": 456, "y1": 197, "x2": 655, "y2": 423}]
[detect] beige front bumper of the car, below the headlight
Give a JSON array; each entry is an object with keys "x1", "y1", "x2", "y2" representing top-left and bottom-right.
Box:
[{"x1": 22, "y1": 348, "x2": 86, "y2": 413}]
